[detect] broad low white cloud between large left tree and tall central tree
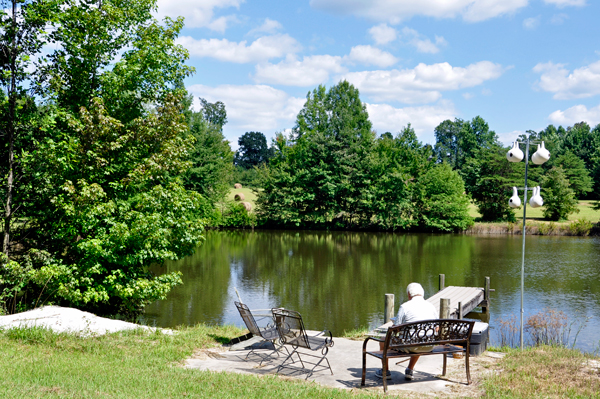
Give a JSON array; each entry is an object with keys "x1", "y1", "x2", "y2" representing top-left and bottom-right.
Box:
[{"x1": 187, "y1": 85, "x2": 306, "y2": 147}]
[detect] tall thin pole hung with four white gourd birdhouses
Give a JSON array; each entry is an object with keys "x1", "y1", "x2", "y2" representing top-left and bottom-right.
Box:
[{"x1": 506, "y1": 134, "x2": 550, "y2": 350}]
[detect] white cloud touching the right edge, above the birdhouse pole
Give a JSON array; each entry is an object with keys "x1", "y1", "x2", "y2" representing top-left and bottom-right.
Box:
[{"x1": 533, "y1": 61, "x2": 600, "y2": 100}]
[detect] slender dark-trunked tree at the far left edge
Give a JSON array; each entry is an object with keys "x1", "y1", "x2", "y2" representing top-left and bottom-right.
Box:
[{"x1": 0, "y1": 0, "x2": 58, "y2": 258}]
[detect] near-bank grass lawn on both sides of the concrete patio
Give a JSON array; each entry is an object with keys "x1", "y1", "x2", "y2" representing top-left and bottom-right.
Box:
[{"x1": 0, "y1": 325, "x2": 600, "y2": 399}]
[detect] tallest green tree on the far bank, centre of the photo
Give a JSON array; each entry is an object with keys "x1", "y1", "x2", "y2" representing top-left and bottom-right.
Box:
[{"x1": 257, "y1": 81, "x2": 375, "y2": 228}]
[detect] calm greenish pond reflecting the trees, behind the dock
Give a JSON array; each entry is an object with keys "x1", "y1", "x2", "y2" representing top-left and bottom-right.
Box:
[{"x1": 143, "y1": 230, "x2": 600, "y2": 352}]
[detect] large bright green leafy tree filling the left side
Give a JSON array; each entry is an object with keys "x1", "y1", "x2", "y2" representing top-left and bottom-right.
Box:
[{"x1": 0, "y1": 0, "x2": 210, "y2": 316}]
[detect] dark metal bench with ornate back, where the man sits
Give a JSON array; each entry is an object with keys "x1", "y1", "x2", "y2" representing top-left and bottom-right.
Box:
[{"x1": 361, "y1": 319, "x2": 475, "y2": 392}]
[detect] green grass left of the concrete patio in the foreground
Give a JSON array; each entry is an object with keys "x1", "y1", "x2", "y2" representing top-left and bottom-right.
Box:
[{"x1": 0, "y1": 325, "x2": 372, "y2": 399}]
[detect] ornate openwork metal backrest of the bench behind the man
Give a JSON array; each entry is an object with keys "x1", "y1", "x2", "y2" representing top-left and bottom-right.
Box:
[{"x1": 384, "y1": 319, "x2": 475, "y2": 350}]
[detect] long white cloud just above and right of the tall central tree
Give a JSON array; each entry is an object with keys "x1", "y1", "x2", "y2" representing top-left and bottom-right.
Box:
[{"x1": 342, "y1": 61, "x2": 505, "y2": 104}]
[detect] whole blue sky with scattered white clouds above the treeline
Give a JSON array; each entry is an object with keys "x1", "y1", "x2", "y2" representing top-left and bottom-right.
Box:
[{"x1": 158, "y1": 0, "x2": 600, "y2": 149}]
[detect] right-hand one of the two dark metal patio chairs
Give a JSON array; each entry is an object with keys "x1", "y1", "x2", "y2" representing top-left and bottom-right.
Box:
[{"x1": 271, "y1": 309, "x2": 333, "y2": 379}]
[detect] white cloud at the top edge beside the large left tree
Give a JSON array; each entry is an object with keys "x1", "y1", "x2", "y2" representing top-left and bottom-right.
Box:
[{"x1": 157, "y1": 0, "x2": 244, "y2": 33}]
